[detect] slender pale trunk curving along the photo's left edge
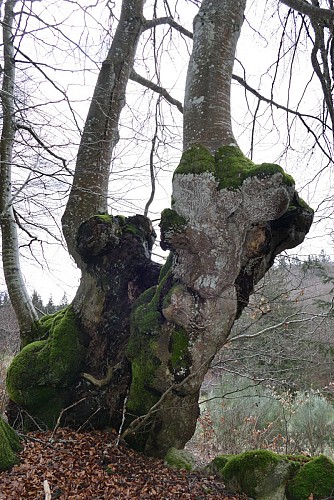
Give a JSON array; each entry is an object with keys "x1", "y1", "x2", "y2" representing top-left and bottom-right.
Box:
[{"x1": 0, "y1": 0, "x2": 37, "y2": 343}]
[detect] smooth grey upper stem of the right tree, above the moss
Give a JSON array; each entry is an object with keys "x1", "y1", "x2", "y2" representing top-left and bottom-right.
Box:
[{"x1": 183, "y1": 0, "x2": 246, "y2": 152}]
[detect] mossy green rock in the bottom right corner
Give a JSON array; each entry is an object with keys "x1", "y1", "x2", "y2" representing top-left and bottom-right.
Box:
[{"x1": 287, "y1": 455, "x2": 334, "y2": 500}]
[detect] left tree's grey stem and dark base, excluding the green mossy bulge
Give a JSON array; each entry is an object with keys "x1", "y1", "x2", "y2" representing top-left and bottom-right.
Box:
[{"x1": 58, "y1": 0, "x2": 152, "y2": 427}]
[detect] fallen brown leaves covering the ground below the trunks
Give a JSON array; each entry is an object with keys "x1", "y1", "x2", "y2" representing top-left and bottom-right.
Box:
[{"x1": 0, "y1": 429, "x2": 250, "y2": 500}]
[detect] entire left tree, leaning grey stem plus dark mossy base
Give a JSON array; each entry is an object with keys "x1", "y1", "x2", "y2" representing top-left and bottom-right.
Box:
[{"x1": 7, "y1": 0, "x2": 160, "y2": 434}]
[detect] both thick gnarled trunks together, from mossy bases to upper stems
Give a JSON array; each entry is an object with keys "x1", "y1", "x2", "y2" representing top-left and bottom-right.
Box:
[{"x1": 8, "y1": 0, "x2": 312, "y2": 456}]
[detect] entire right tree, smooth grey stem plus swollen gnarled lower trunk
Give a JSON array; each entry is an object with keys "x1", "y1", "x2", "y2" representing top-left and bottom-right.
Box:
[{"x1": 125, "y1": 0, "x2": 313, "y2": 456}]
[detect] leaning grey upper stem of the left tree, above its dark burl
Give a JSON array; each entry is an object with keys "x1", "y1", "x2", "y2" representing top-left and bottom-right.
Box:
[{"x1": 62, "y1": 0, "x2": 144, "y2": 264}]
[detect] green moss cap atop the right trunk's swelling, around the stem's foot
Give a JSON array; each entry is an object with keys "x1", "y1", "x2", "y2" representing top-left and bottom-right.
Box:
[{"x1": 174, "y1": 145, "x2": 294, "y2": 190}]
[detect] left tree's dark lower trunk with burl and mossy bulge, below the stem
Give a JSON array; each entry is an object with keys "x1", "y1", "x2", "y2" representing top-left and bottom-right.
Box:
[{"x1": 7, "y1": 215, "x2": 160, "y2": 428}]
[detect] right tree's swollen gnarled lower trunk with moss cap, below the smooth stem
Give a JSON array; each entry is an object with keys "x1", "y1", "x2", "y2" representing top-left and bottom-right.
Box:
[{"x1": 122, "y1": 145, "x2": 313, "y2": 456}]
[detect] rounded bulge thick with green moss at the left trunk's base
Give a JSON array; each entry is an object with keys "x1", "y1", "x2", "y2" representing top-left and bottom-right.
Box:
[{"x1": 7, "y1": 307, "x2": 85, "y2": 428}]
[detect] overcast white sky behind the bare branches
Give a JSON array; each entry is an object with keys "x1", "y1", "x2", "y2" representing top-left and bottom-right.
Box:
[{"x1": 0, "y1": 0, "x2": 333, "y2": 303}]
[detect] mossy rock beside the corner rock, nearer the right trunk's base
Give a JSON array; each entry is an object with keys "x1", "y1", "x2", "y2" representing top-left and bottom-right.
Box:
[{"x1": 215, "y1": 450, "x2": 294, "y2": 500}]
